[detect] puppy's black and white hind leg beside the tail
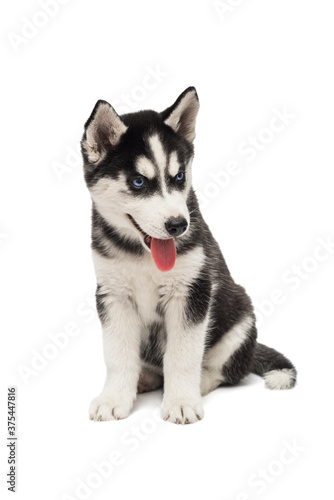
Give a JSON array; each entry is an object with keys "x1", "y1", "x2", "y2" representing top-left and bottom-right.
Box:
[{"x1": 201, "y1": 316, "x2": 256, "y2": 396}]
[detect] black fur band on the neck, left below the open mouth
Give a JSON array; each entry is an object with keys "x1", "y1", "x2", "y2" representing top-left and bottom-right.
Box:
[{"x1": 92, "y1": 206, "x2": 144, "y2": 256}]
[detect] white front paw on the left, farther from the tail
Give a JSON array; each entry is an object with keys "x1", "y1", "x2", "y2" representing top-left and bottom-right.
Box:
[{"x1": 89, "y1": 394, "x2": 133, "y2": 422}]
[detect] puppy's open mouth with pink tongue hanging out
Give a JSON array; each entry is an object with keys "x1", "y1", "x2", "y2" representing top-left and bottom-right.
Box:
[{"x1": 127, "y1": 214, "x2": 176, "y2": 271}]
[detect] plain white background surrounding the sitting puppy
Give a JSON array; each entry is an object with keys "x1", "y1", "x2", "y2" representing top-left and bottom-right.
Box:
[{"x1": 0, "y1": 0, "x2": 334, "y2": 500}]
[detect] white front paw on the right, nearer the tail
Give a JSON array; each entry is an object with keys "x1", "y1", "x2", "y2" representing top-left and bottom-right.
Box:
[{"x1": 161, "y1": 399, "x2": 204, "y2": 424}]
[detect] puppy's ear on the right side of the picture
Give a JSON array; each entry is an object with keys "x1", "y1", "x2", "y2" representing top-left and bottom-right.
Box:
[{"x1": 161, "y1": 87, "x2": 199, "y2": 142}]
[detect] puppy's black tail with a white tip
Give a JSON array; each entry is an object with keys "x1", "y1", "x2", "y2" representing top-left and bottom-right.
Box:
[{"x1": 251, "y1": 343, "x2": 297, "y2": 389}]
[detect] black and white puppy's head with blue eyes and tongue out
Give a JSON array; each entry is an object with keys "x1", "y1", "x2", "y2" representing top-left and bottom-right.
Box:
[{"x1": 81, "y1": 87, "x2": 199, "y2": 270}]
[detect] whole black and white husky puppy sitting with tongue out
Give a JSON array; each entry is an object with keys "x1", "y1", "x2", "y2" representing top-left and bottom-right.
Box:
[{"x1": 81, "y1": 87, "x2": 296, "y2": 424}]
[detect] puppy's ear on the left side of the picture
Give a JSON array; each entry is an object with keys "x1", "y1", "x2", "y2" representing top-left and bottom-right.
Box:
[{"x1": 81, "y1": 100, "x2": 127, "y2": 165}]
